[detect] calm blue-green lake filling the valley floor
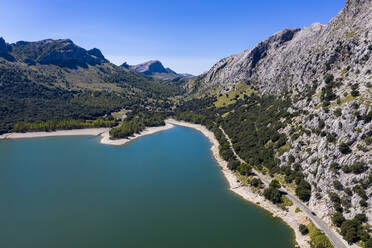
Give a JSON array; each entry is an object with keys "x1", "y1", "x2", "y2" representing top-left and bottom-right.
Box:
[{"x1": 0, "y1": 126, "x2": 294, "y2": 248}]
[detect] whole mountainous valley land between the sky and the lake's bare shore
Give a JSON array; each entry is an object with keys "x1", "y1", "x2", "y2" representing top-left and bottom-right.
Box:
[{"x1": 0, "y1": 0, "x2": 372, "y2": 248}]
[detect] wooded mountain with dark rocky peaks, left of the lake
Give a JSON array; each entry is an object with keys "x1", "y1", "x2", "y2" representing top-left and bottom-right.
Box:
[{"x1": 0, "y1": 38, "x2": 179, "y2": 132}]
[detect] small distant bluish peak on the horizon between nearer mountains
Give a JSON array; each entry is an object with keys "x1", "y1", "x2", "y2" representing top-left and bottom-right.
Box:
[{"x1": 126, "y1": 60, "x2": 192, "y2": 80}]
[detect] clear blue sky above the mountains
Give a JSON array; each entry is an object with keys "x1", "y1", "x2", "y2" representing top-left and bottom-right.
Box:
[{"x1": 0, "y1": 0, "x2": 345, "y2": 74}]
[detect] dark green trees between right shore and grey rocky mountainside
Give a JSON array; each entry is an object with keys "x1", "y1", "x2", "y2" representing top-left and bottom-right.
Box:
[{"x1": 176, "y1": 94, "x2": 311, "y2": 203}]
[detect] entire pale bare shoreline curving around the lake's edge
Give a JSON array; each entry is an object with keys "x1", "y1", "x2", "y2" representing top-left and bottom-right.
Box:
[{"x1": 0, "y1": 119, "x2": 310, "y2": 248}]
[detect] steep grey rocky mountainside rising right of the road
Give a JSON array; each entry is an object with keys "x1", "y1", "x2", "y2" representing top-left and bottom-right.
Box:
[{"x1": 185, "y1": 0, "x2": 372, "y2": 234}]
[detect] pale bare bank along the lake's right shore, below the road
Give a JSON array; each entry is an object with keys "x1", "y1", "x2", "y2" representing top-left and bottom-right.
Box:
[{"x1": 166, "y1": 119, "x2": 310, "y2": 248}]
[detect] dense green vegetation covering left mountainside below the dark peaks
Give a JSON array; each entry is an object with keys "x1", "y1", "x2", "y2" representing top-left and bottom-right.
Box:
[{"x1": 0, "y1": 58, "x2": 181, "y2": 134}]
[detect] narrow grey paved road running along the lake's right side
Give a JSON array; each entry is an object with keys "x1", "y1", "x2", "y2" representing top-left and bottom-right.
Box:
[{"x1": 220, "y1": 127, "x2": 346, "y2": 248}]
